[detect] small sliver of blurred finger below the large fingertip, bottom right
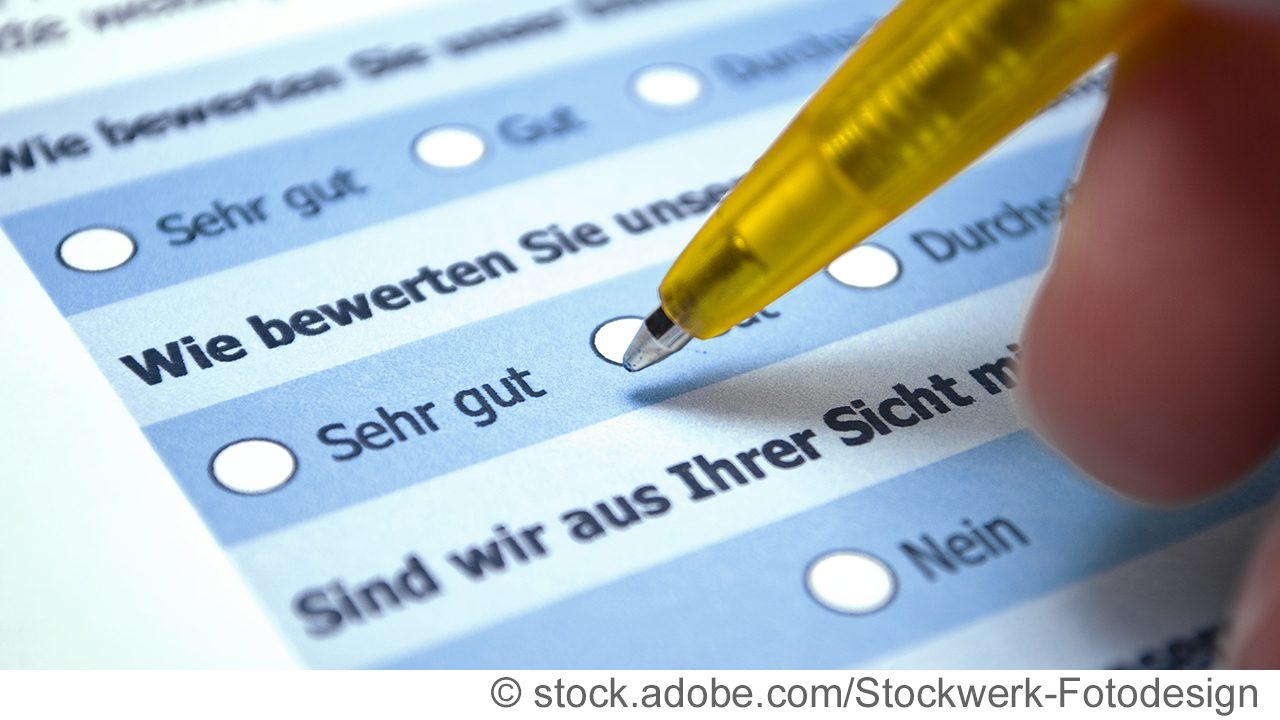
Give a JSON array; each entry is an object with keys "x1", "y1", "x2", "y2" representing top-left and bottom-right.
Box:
[{"x1": 1224, "y1": 502, "x2": 1280, "y2": 667}]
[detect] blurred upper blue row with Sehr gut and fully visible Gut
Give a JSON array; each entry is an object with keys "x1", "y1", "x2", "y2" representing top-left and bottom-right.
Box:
[{"x1": 3, "y1": 1, "x2": 870, "y2": 315}]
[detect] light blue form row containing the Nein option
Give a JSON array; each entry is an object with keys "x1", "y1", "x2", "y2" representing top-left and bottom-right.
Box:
[{"x1": 381, "y1": 432, "x2": 1280, "y2": 669}]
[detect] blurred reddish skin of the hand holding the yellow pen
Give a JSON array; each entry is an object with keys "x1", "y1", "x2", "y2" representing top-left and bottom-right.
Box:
[{"x1": 1021, "y1": 3, "x2": 1280, "y2": 667}]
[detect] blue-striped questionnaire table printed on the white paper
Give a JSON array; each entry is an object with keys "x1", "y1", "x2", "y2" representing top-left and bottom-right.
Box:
[{"x1": 0, "y1": 0, "x2": 1280, "y2": 667}]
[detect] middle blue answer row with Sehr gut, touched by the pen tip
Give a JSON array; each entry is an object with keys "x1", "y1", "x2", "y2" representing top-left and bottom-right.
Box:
[{"x1": 145, "y1": 131, "x2": 1083, "y2": 544}]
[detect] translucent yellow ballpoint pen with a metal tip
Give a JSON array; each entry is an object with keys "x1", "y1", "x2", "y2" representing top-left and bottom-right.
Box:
[{"x1": 623, "y1": 0, "x2": 1178, "y2": 372}]
